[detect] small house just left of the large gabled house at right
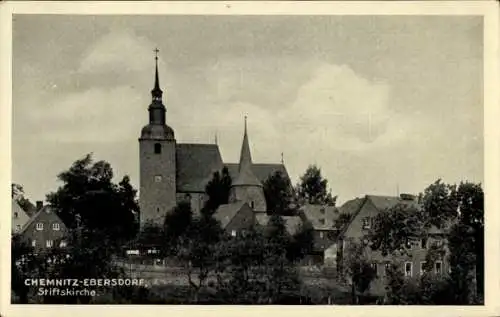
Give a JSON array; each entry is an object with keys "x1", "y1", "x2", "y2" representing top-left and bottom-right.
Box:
[{"x1": 299, "y1": 204, "x2": 339, "y2": 266}]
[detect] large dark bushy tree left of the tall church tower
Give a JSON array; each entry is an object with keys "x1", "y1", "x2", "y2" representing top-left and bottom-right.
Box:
[{"x1": 47, "y1": 154, "x2": 139, "y2": 244}]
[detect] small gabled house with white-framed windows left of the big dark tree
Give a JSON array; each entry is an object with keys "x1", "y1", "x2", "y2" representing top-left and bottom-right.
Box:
[{"x1": 20, "y1": 205, "x2": 68, "y2": 252}]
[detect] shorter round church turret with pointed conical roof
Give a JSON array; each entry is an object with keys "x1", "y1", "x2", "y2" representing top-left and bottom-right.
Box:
[{"x1": 229, "y1": 117, "x2": 267, "y2": 212}]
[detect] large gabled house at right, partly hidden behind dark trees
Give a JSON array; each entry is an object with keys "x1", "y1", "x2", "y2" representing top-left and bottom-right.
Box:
[{"x1": 337, "y1": 195, "x2": 449, "y2": 295}]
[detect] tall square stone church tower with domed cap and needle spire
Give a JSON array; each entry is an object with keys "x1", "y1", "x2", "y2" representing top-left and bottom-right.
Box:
[{"x1": 139, "y1": 49, "x2": 176, "y2": 227}]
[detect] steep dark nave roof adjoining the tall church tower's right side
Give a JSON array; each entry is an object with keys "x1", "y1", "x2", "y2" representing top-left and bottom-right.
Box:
[{"x1": 176, "y1": 143, "x2": 224, "y2": 193}]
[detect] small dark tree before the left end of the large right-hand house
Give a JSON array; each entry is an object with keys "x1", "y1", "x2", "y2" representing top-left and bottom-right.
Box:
[{"x1": 342, "y1": 241, "x2": 377, "y2": 304}]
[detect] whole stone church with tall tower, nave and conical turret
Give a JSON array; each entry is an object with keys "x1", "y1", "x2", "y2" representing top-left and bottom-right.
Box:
[{"x1": 139, "y1": 56, "x2": 289, "y2": 225}]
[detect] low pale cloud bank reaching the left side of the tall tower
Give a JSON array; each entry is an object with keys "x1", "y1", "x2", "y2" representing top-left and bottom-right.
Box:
[{"x1": 28, "y1": 87, "x2": 146, "y2": 143}]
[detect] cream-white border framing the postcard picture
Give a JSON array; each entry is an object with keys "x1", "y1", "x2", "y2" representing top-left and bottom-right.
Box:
[{"x1": 0, "y1": 1, "x2": 500, "y2": 317}]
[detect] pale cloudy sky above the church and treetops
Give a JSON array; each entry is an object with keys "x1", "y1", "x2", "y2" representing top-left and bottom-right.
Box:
[{"x1": 12, "y1": 15, "x2": 484, "y2": 203}]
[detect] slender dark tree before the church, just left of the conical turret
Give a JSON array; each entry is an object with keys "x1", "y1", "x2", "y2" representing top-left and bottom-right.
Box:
[{"x1": 202, "y1": 167, "x2": 232, "y2": 214}]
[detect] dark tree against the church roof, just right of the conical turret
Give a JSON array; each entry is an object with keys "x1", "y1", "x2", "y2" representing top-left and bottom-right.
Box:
[{"x1": 264, "y1": 171, "x2": 293, "y2": 216}]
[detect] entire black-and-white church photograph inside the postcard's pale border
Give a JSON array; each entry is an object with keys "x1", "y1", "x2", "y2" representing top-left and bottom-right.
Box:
[{"x1": 2, "y1": 2, "x2": 498, "y2": 306}]
